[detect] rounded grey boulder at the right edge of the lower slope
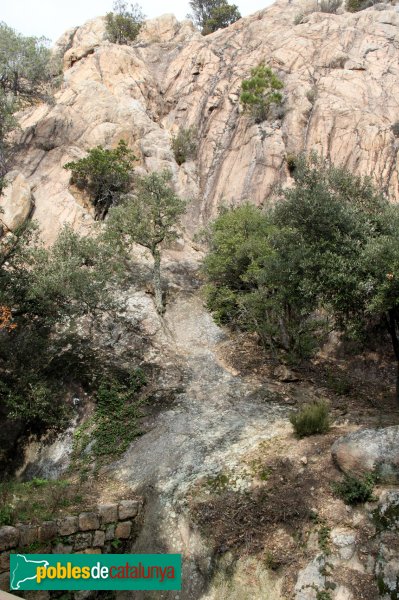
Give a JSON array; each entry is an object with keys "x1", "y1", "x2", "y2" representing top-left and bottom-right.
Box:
[{"x1": 331, "y1": 425, "x2": 399, "y2": 483}]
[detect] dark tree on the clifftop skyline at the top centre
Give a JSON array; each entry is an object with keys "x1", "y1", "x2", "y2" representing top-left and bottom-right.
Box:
[{"x1": 188, "y1": 0, "x2": 241, "y2": 35}]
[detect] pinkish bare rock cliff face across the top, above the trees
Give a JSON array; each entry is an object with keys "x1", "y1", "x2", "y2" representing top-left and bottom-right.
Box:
[{"x1": 5, "y1": 0, "x2": 399, "y2": 239}]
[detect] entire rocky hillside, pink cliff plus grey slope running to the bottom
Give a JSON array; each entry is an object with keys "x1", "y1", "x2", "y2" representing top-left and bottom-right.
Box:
[{"x1": 2, "y1": 0, "x2": 399, "y2": 600}]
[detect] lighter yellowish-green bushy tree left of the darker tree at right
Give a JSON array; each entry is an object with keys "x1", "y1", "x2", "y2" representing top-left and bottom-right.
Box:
[{"x1": 203, "y1": 204, "x2": 328, "y2": 360}]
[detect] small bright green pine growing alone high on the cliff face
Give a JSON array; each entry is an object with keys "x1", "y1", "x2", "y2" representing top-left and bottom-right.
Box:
[{"x1": 240, "y1": 64, "x2": 284, "y2": 123}]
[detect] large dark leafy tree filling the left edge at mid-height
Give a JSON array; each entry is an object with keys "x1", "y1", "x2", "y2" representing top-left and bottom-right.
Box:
[{"x1": 0, "y1": 224, "x2": 117, "y2": 432}]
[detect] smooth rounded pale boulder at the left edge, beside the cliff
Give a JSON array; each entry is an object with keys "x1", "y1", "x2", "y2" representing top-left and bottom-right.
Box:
[{"x1": 0, "y1": 172, "x2": 34, "y2": 231}]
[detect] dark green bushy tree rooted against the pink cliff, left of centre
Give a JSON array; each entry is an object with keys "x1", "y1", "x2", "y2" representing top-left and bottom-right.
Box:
[{"x1": 64, "y1": 140, "x2": 137, "y2": 219}]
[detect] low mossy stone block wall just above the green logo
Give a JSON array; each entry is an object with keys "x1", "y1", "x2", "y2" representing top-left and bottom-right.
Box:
[{"x1": 0, "y1": 500, "x2": 143, "y2": 591}]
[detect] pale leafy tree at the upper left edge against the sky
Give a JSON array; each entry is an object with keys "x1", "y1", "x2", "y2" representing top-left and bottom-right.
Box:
[{"x1": 0, "y1": 23, "x2": 53, "y2": 102}]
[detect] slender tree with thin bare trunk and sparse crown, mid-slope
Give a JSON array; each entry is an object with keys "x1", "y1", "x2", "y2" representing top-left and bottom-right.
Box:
[{"x1": 107, "y1": 171, "x2": 186, "y2": 314}]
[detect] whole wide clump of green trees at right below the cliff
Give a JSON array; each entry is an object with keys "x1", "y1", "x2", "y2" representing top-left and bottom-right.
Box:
[{"x1": 204, "y1": 155, "x2": 399, "y2": 399}]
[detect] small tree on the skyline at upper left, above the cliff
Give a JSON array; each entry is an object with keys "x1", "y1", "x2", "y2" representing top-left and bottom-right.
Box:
[{"x1": 105, "y1": 0, "x2": 145, "y2": 44}]
